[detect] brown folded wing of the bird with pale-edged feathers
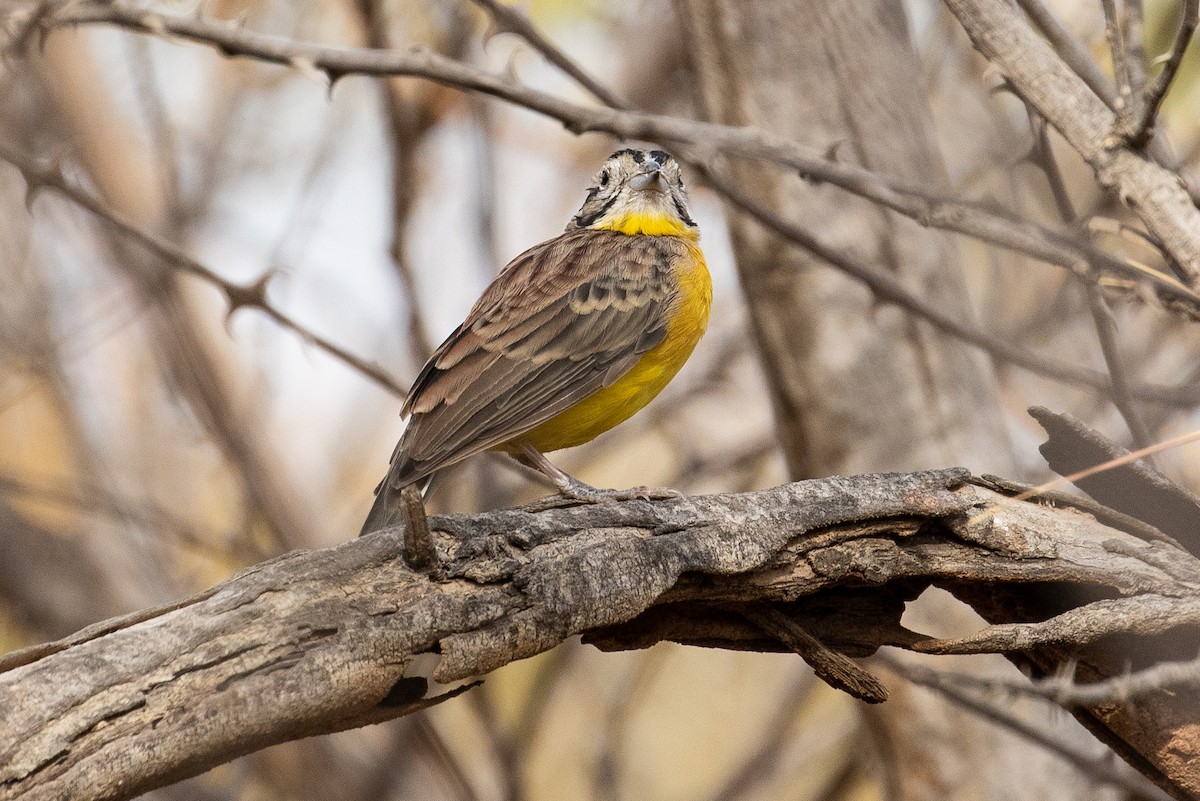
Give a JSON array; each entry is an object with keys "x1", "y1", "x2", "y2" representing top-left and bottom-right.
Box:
[{"x1": 385, "y1": 230, "x2": 680, "y2": 488}]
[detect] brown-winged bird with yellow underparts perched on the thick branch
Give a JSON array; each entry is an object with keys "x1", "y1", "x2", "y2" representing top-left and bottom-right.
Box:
[{"x1": 362, "y1": 147, "x2": 713, "y2": 534}]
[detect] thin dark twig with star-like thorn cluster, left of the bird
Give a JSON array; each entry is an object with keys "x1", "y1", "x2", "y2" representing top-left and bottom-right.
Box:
[{"x1": 0, "y1": 143, "x2": 406, "y2": 397}]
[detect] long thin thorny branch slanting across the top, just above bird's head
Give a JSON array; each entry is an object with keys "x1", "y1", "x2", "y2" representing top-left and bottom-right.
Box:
[{"x1": 35, "y1": 2, "x2": 1200, "y2": 309}]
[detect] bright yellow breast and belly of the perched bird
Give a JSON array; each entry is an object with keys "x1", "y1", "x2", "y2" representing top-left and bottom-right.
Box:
[{"x1": 521, "y1": 228, "x2": 713, "y2": 452}]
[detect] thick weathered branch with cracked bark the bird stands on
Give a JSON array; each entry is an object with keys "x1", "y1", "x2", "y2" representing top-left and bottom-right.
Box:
[{"x1": 7, "y1": 470, "x2": 1200, "y2": 801}]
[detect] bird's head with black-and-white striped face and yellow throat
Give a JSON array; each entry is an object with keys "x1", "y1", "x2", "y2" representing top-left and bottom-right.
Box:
[{"x1": 568, "y1": 149, "x2": 697, "y2": 237}]
